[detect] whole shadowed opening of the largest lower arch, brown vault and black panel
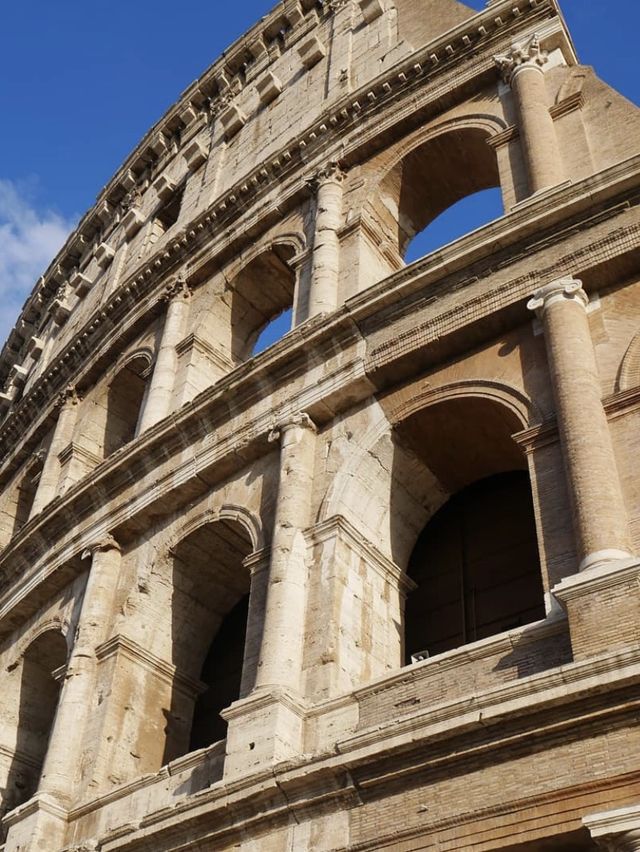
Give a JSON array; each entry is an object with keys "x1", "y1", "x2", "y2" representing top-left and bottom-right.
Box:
[{"x1": 397, "y1": 395, "x2": 545, "y2": 663}]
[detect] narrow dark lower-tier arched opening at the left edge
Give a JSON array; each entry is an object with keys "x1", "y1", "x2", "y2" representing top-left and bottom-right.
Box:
[{"x1": 2, "y1": 630, "x2": 67, "y2": 813}]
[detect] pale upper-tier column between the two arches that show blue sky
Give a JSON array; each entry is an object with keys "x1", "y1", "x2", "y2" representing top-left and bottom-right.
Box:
[{"x1": 308, "y1": 163, "x2": 344, "y2": 317}]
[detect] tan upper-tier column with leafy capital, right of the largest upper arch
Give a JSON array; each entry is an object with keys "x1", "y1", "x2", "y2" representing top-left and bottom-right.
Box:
[{"x1": 495, "y1": 35, "x2": 565, "y2": 195}]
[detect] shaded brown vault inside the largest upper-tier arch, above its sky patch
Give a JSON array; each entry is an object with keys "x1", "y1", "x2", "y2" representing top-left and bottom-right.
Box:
[{"x1": 376, "y1": 127, "x2": 500, "y2": 257}]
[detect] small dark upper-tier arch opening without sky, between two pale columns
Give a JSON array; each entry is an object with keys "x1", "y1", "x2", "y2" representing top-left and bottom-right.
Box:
[{"x1": 104, "y1": 355, "x2": 149, "y2": 458}]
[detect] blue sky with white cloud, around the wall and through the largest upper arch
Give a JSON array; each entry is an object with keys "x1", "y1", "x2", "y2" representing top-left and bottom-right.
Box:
[{"x1": 0, "y1": 0, "x2": 640, "y2": 340}]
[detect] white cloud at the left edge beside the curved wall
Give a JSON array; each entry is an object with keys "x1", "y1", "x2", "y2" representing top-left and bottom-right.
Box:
[{"x1": 0, "y1": 178, "x2": 74, "y2": 349}]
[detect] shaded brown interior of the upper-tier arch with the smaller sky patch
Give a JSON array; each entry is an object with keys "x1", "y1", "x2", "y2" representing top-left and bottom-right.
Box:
[{"x1": 231, "y1": 244, "x2": 296, "y2": 363}]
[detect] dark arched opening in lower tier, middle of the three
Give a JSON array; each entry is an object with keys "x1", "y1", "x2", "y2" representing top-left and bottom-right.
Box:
[{"x1": 164, "y1": 519, "x2": 257, "y2": 762}]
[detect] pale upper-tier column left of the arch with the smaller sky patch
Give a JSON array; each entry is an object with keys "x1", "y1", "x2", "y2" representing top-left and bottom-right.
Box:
[{"x1": 138, "y1": 278, "x2": 191, "y2": 434}]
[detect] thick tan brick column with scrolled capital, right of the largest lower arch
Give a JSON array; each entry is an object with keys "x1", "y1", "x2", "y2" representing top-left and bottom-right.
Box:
[{"x1": 528, "y1": 278, "x2": 631, "y2": 570}]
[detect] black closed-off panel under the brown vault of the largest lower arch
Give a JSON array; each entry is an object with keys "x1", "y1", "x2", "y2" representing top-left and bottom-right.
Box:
[{"x1": 405, "y1": 470, "x2": 545, "y2": 663}]
